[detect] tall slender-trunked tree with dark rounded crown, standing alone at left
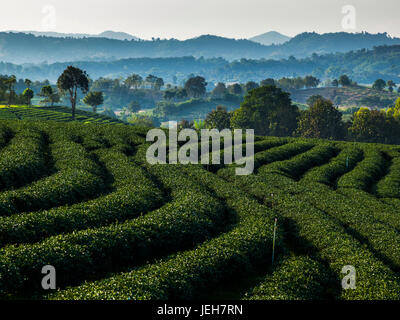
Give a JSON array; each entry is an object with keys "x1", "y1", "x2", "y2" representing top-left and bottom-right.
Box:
[{"x1": 57, "y1": 66, "x2": 89, "y2": 120}]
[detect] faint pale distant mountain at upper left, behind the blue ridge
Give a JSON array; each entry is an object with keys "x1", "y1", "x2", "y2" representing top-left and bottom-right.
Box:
[{"x1": 5, "y1": 30, "x2": 140, "y2": 41}]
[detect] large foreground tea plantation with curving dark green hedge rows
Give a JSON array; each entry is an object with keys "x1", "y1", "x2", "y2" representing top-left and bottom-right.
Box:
[{"x1": 0, "y1": 121, "x2": 400, "y2": 299}]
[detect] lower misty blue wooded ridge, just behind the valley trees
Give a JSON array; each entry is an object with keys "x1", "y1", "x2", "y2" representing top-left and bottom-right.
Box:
[{"x1": 0, "y1": 45, "x2": 400, "y2": 84}]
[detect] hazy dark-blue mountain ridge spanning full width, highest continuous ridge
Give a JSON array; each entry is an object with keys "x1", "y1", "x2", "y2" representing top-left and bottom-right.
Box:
[{"x1": 0, "y1": 32, "x2": 400, "y2": 64}]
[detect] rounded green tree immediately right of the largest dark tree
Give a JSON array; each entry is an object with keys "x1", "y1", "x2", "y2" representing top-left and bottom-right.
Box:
[{"x1": 297, "y1": 96, "x2": 344, "y2": 139}]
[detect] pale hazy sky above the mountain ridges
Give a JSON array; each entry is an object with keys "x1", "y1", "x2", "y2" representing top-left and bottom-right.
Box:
[{"x1": 0, "y1": 0, "x2": 400, "y2": 39}]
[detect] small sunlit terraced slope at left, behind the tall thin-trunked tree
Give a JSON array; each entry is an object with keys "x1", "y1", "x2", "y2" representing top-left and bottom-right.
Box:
[{"x1": 0, "y1": 105, "x2": 123, "y2": 124}]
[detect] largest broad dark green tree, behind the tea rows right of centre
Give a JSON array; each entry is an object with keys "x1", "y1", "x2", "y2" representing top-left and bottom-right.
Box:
[{"x1": 231, "y1": 85, "x2": 299, "y2": 136}]
